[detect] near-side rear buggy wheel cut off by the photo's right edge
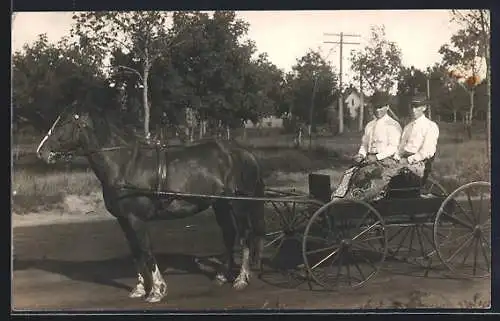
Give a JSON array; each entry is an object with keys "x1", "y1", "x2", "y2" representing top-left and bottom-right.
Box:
[{"x1": 434, "y1": 182, "x2": 491, "y2": 277}]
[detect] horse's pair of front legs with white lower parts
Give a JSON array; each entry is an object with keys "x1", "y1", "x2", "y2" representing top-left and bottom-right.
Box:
[{"x1": 117, "y1": 214, "x2": 167, "y2": 303}]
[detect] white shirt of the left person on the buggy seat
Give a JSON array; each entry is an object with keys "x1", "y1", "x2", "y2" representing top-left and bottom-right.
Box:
[{"x1": 358, "y1": 114, "x2": 401, "y2": 160}]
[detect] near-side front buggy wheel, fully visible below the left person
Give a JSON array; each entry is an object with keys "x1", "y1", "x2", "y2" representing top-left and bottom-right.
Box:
[{"x1": 302, "y1": 199, "x2": 387, "y2": 289}]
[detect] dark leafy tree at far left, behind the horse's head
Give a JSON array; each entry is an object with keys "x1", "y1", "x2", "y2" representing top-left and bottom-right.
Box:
[{"x1": 12, "y1": 34, "x2": 116, "y2": 130}]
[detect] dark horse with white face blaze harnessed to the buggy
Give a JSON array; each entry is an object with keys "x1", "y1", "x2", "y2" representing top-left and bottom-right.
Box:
[{"x1": 36, "y1": 105, "x2": 265, "y2": 303}]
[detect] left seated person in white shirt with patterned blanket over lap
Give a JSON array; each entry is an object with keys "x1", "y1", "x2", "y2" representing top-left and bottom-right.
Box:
[{"x1": 332, "y1": 95, "x2": 401, "y2": 200}]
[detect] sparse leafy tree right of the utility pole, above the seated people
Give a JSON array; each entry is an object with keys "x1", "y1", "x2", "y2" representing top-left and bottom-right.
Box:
[{"x1": 350, "y1": 25, "x2": 401, "y2": 97}]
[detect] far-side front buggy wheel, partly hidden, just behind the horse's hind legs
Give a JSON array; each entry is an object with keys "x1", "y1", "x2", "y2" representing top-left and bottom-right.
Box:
[{"x1": 261, "y1": 200, "x2": 322, "y2": 287}]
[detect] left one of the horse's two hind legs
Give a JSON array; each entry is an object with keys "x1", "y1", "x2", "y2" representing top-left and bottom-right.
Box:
[{"x1": 213, "y1": 201, "x2": 237, "y2": 285}]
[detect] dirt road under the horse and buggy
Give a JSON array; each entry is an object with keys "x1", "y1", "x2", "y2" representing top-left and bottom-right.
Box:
[{"x1": 12, "y1": 211, "x2": 491, "y2": 311}]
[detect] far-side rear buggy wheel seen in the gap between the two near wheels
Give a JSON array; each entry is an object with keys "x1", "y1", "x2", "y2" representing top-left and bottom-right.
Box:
[{"x1": 387, "y1": 177, "x2": 449, "y2": 268}]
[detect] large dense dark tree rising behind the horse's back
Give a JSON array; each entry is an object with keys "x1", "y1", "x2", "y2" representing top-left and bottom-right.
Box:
[{"x1": 164, "y1": 11, "x2": 279, "y2": 136}]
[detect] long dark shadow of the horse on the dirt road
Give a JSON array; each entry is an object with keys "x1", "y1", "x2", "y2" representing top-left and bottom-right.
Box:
[{"x1": 13, "y1": 253, "x2": 227, "y2": 290}]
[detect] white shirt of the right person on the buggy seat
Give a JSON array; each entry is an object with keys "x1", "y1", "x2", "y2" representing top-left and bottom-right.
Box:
[{"x1": 394, "y1": 115, "x2": 439, "y2": 164}]
